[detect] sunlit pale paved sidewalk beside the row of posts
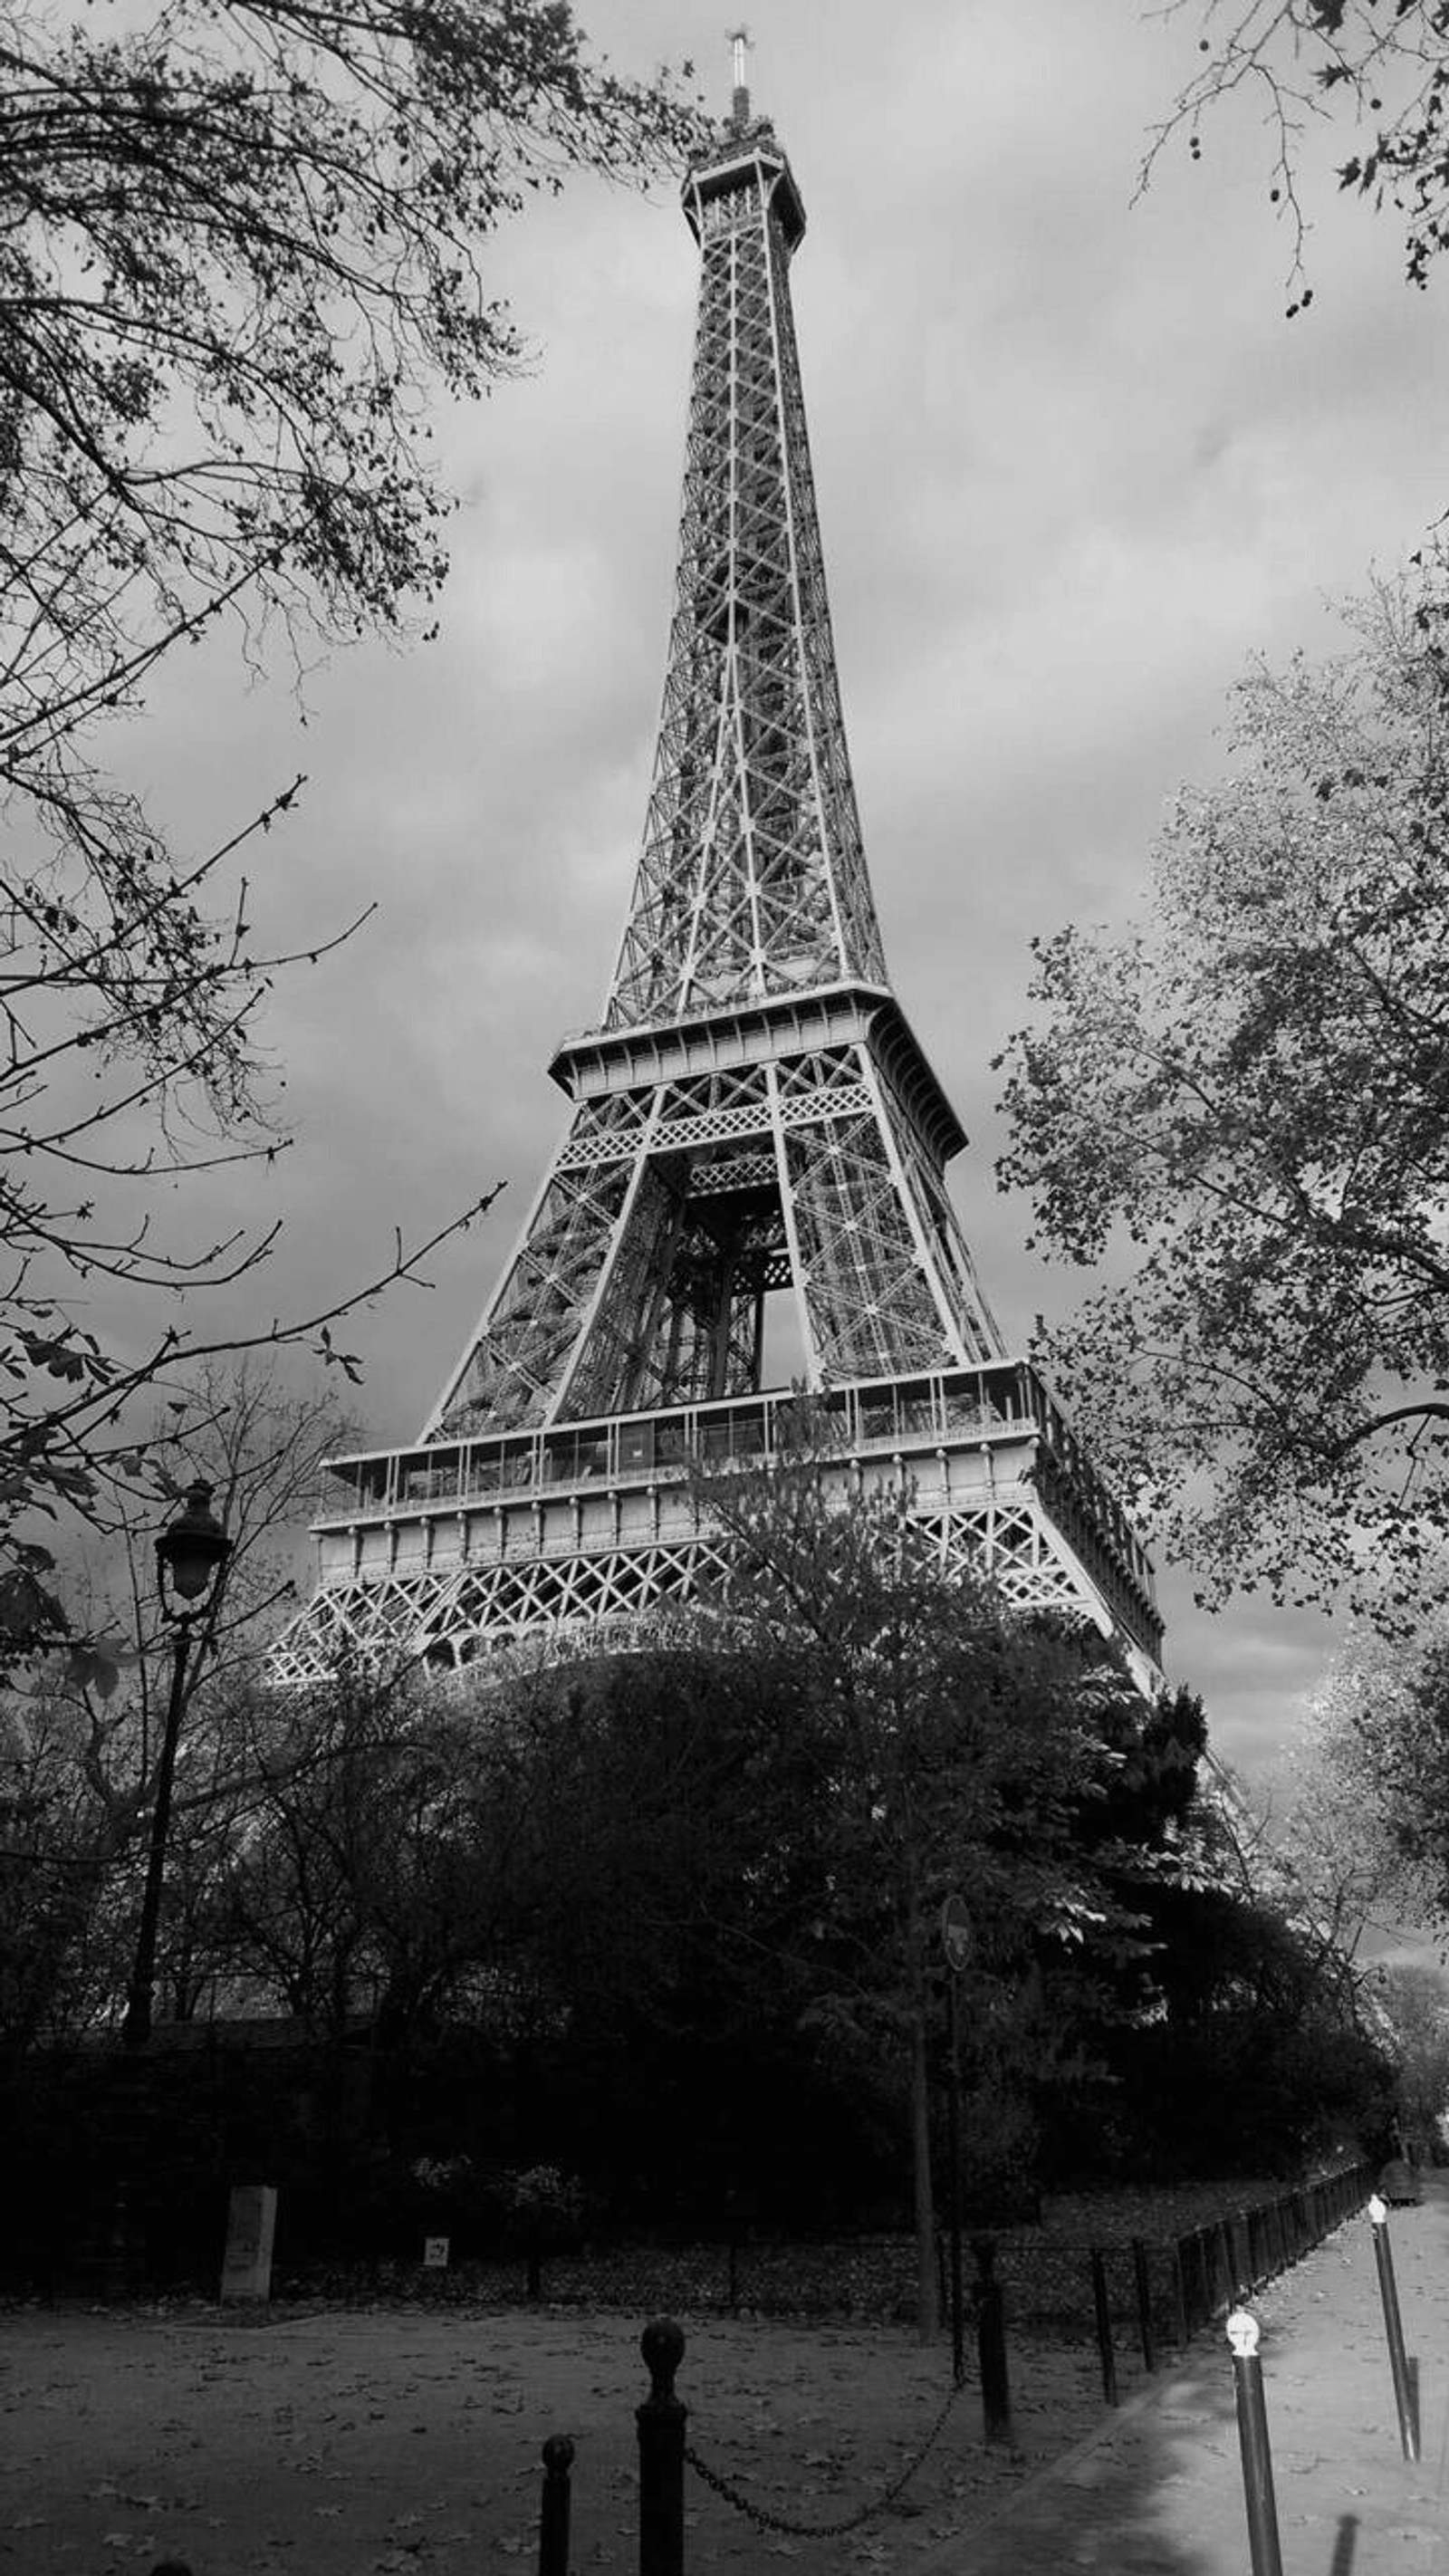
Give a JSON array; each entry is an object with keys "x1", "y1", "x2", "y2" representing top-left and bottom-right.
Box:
[{"x1": 926, "y1": 2174, "x2": 1449, "y2": 2576}]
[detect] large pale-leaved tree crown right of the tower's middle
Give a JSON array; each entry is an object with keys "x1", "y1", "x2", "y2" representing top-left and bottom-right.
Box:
[{"x1": 1002, "y1": 585, "x2": 1449, "y2": 1612}]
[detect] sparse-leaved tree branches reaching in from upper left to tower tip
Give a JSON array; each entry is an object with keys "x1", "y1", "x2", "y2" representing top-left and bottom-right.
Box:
[{"x1": 0, "y1": 0, "x2": 695, "y2": 1651}]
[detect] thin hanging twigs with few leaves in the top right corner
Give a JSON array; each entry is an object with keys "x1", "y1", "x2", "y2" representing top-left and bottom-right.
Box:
[{"x1": 1143, "y1": 0, "x2": 1449, "y2": 298}]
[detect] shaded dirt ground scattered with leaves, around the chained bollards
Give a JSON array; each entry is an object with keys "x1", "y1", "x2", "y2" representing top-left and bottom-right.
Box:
[{"x1": 0, "y1": 2308, "x2": 1099, "y2": 2576}]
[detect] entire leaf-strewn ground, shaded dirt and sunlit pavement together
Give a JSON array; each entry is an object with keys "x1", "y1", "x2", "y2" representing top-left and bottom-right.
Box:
[{"x1": 0, "y1": 2177, "x2": 1449, "y2": 2576}]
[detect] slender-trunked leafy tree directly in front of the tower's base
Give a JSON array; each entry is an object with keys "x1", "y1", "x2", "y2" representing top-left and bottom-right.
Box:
[{"x1": 684, "y1": 1435, "x2": 1171, "y2": 2334}]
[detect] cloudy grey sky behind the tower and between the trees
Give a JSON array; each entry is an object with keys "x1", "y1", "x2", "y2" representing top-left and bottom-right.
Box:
[{"x1": 123, "y1": 0, "x2": 1449, "y2": 1773}]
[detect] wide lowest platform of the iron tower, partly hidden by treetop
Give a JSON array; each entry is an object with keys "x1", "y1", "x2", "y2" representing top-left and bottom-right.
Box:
[{"x1": 273, "y1": 1360, "x2": 1161, "y2": 1690}]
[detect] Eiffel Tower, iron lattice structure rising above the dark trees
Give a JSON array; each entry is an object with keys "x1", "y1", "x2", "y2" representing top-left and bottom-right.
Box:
[{"x1": 273, "y1": 55, "x2": 1161, "y2": 1687}]
